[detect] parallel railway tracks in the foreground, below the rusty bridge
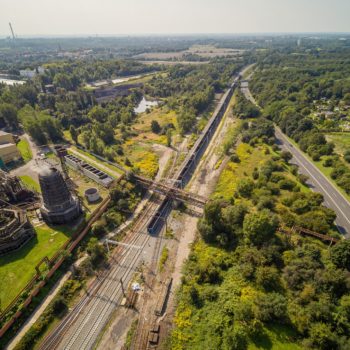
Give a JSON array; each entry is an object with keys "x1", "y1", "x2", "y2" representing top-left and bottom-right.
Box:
[{"x1": 40, "y1": 194, "x2": 163, "y2": 350}]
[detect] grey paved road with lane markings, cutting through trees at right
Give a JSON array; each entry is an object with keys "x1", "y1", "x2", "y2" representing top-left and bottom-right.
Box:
[{"x1": 275, "y1": 128, "x2": 350, "y2": 239}]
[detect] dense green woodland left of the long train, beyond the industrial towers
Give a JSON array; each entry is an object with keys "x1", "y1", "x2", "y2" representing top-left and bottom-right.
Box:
[{"x1": 0, "y1": 59, "x2": 242, "y2": 171}]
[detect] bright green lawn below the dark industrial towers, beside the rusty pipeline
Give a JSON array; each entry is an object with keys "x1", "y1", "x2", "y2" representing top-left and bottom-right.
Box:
[{"x1": 0, "y1": 225, "x2": 70, "y2": 309}]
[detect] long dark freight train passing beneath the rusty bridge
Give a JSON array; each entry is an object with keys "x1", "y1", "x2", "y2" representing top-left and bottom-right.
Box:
[{"x1": 147, "y1": 75, "x2": 240, "y2": 234}]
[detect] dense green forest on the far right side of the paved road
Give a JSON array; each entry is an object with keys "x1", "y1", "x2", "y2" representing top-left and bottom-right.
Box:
[{"x1": 250, "y1": 49, "x2": 350, "y2": 194}]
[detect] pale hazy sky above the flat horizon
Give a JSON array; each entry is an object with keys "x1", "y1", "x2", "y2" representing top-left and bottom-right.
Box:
[{"x1": 0, "y1": 0, "x2": 350, "y2": 36}]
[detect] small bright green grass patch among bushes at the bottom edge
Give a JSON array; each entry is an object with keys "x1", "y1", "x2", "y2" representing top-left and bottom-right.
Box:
[{"x1": 248, "y1": 325, "x2": 303, "y2": 350}]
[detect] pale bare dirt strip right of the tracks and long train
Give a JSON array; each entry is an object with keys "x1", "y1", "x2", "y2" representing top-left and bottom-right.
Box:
[{"x1": 97, "y1": 73, "x2": 239, "y2": 349}]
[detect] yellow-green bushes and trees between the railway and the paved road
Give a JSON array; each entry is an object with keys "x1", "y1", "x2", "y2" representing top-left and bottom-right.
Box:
[{"x1": 171, "y1": 118, "x2": 350, "y2": 350}]
